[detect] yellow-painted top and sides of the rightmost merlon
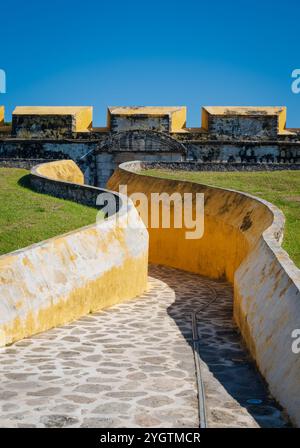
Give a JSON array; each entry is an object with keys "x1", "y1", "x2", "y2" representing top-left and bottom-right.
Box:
[{"x1": 202, "y1": 106, "x2": 286, "y2": 133}]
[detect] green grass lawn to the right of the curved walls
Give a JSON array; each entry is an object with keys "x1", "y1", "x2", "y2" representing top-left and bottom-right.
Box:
[{"x1": 143, "y1": 170, "x2": 300, "y2": 267}]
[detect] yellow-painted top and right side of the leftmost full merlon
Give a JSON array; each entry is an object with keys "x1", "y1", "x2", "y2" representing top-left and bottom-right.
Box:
[{"x1": 13, "y1": 106, "x2": 93, "y2": 132}]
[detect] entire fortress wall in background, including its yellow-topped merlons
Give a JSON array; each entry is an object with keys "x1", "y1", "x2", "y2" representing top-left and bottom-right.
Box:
[{"x1": 0, "y1": 106, "x2": 300, "y2": 186}]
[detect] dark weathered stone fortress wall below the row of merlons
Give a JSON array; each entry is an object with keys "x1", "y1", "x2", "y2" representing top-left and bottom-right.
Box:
[{"x1": 0, "y1": 136, "x2": 300, "y2": 187}]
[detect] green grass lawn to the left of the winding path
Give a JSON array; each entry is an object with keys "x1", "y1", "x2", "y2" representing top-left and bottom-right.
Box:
[{"x1": 0, "y1": 168, "x2": 101, "y2": 255}]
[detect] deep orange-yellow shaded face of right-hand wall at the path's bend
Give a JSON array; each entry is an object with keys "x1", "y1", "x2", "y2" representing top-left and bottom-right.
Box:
[{"x1": 108, "y1": 164, "x2": 272, "y2": 282}]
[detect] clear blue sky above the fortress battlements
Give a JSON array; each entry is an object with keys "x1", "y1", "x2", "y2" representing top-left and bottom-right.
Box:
[{"x1": 0, "y1": 0, "x2": 300, "y2": 127}]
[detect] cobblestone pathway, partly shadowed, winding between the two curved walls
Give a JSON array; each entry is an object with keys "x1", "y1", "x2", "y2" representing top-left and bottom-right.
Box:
[{"x1": 0, "y1": 266, "x2": 286, "y2": 427}]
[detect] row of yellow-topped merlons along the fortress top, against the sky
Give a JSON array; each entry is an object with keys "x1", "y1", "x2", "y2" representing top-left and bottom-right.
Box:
[{"x1": 0, "y1": 106, "x2": 292, "y2": 140}]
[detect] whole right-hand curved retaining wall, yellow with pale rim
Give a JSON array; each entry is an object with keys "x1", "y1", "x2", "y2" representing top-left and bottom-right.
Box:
[{"x1": 108, "y1": 162, "x2": 300, "y2": 426}]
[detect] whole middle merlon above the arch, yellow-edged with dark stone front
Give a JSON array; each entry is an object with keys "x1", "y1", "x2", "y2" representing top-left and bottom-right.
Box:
[{"x1": 107, "y1": 106, "x2": 186, "y2": 132}]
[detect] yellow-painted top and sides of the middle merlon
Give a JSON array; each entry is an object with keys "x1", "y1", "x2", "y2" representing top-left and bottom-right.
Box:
[{"x1": 107, "y1": 106, "x2": 186, "y2": 132}]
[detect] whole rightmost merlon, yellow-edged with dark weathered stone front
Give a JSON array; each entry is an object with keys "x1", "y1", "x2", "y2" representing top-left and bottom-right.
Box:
[{"x1": 202, "y1": 106, "x2": 286, "y2": 138}]
